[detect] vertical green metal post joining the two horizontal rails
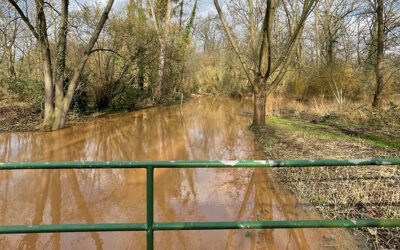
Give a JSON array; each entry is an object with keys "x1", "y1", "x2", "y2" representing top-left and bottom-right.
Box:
[{"x1": 146, "y1": 166, "x2": 154, "y2": 250}]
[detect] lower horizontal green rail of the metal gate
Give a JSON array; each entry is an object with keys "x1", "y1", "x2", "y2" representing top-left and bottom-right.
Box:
[{"x1": 0, "y1": 219, "x2": 400, "y2": 234}]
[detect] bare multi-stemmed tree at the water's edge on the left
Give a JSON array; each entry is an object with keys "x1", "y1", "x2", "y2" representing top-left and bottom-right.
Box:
[{"x1": 8, "y1": 0, "x2": 114, "y2": 130}]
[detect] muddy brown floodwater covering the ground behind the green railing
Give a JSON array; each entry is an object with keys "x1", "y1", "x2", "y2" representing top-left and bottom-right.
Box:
[{"x1": 0, "y1": 98, "x2": 357, "y2": 249}]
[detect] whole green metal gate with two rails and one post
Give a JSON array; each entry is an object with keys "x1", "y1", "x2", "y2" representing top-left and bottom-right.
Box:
[{"x1": 0, "y1": 158, "x2": 400, "y2": 249}]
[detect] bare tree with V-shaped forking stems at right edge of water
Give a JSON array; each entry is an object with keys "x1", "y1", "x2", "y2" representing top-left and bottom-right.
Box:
[{"x1": 214, "y1": 0, "x2": 317, "y2": 126}]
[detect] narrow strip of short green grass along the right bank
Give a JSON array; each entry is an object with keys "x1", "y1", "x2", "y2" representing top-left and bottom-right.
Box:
[{"x1": 266, "y1": 117, "x2": 400, "y2": 149}]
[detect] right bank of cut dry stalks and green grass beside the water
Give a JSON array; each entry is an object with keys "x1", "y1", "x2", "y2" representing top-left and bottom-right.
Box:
[{"x1": 258, "y1": 112, "x2": 400, "y2": 248}]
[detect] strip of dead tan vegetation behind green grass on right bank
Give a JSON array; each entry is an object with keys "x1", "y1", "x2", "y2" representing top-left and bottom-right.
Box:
[{"x1": 267, "y1": 96, "x2": 400, "y2": 146}]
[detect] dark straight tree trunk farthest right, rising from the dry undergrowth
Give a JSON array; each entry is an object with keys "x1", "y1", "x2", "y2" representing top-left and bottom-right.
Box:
[{"x1": 372, "y1": 0, "x2": 385, "y2": 108}]
